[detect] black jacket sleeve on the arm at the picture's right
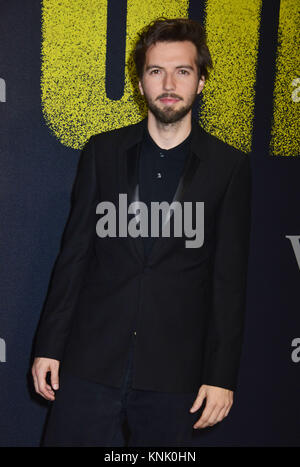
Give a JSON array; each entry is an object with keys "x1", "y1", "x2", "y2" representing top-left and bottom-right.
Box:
[{"x1": 203, "y1": 153, "x2": 252, "y2": 390}]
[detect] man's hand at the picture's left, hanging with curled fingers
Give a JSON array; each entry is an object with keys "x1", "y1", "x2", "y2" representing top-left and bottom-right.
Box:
[{"x1": 31, "y1": 357, "x2": 60, "y2": 401}]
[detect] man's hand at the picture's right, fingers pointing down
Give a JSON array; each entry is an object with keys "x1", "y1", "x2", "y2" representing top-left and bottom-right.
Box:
[{"x1": 190, "y1": 384, "x2": 233, "y2": 428}]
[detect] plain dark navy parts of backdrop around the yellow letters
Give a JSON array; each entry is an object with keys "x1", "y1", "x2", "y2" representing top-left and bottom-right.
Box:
[{"x1": 0, "y1": 0, "x2": 300, "y2": 446}]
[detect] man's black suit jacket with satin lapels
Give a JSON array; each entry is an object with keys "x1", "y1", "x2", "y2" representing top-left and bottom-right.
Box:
[{"x1": 35, "y1": 118, "x2": 251, "y2": 392}]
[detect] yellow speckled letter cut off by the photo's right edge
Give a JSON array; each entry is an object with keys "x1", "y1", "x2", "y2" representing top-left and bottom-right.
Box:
[{"x1": 270, "y1": 0, "x2": 300, "y2": 156}]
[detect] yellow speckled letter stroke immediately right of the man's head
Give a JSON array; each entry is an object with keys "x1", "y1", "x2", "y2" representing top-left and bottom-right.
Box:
[{"x1": 199, "y1": 0, "x2": 261, "y2": 152}]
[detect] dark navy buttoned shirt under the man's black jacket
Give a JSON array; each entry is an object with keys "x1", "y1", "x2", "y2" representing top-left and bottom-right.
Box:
[{"x1": 139, "y1": 126, "x2": 191, "y2": 257}]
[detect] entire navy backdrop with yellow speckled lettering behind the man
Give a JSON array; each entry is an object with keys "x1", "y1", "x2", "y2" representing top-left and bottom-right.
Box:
[{"x1": 0, "y1": 0, "x2": 300, "y2": 446}]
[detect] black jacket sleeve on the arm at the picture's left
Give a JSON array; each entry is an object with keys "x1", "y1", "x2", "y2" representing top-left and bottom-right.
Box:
[{"x1": 34, "y1": 136, "x2": 98, "y2": 360}]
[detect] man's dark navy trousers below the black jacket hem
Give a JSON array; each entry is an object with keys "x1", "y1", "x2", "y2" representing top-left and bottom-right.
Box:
[{"x1": 42, "y1": 338, "x2": 202, "y2": 447}]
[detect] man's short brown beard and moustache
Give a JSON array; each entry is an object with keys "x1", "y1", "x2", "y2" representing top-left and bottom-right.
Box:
[{"x1": 144, "y1": 91, "x2": 198, "y2": 123}]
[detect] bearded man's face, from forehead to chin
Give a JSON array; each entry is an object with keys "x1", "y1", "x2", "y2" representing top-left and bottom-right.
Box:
[{"x1": 139, "y1": 41, "x2": 205, "y2": 123}]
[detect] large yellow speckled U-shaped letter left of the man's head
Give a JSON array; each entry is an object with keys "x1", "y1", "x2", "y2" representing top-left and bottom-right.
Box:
[{"x1": 41, "y1": 0, "x2": 189, "y2": 149}]
